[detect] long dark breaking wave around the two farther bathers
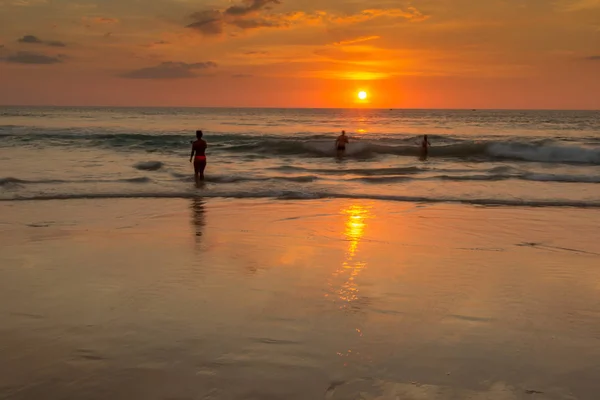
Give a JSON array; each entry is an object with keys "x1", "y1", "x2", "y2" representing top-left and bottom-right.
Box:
[{"x1": 2, "y1": 129, "x2": 600, "y2": 165}]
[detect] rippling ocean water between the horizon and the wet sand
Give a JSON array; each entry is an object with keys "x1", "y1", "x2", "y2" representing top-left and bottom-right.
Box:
[{"x1": 0, "y1": 107, "x2": 600, "y2": 207}]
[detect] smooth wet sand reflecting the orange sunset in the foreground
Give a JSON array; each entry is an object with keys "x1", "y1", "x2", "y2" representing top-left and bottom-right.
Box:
[{"x1": 0, "y1": 198, "x2": 600, "y2": 400}]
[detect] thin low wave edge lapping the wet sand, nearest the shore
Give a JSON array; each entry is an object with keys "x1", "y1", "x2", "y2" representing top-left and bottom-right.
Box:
[{"x1": 0, "y1": 191, "x2": 600, "y2": 208}]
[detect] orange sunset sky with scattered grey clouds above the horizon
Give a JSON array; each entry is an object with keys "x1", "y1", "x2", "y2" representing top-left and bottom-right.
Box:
[{"x1": 0, "y1": 0, "x2": 600, "y2": 110}]
